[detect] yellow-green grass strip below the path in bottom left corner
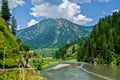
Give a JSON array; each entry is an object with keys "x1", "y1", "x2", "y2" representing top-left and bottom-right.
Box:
[{"x1": 0, "y1": 69, "x2": 46, "y2": 80}]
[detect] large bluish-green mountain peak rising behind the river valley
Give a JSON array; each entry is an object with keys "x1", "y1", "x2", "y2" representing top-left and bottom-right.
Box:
[{"x1": 17, "y1": 18, "x2": 90, "y2": 49}]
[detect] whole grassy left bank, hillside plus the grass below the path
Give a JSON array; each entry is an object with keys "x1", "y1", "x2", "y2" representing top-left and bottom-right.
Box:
[{"x1": 0, "y1": 17, "x2": 45, "y2": 80}]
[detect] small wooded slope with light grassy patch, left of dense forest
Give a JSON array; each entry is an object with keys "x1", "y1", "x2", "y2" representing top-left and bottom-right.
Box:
[{"x1": 55, "y1": 37, "x2": 86, "y2": 60}]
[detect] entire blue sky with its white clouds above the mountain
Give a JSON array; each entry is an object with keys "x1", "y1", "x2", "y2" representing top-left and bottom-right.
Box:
[{"x1": 0, "y1": 0, "x2": 120, "y2": 29}]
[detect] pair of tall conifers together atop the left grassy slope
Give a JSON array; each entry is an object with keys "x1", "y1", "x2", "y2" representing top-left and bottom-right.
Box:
[{"x1": 0, "y1": 0, "x2": 17, "y2": 35}]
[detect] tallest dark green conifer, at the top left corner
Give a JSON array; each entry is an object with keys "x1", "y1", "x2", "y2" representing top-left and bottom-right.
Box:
[{"x1": 1, "y1": 0, "x2": 11, "y2": 22}]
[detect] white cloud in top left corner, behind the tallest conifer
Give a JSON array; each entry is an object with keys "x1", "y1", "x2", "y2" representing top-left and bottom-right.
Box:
[{"x1": 0, "y1": 0, "x2": 25, "y2": 9}]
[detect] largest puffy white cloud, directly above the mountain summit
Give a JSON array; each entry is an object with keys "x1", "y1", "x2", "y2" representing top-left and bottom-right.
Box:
[{"x1": 30, "y1": 0, "x2": 92, "y2": 25}]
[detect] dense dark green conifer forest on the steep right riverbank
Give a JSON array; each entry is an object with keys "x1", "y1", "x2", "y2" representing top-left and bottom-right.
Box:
[{"x1": 78, "y1": 11, "x2": 120, "y2": 64}]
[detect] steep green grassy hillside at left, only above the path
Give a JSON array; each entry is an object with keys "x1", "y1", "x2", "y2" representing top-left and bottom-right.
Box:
[{"x1": 0, "y1": 17, "x2": 22, "y2": 67}]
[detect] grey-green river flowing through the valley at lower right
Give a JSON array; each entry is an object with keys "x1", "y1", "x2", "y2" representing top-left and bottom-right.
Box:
[{"x1": 42, "y1": 62, "x2": 120, "y2": 80}]
